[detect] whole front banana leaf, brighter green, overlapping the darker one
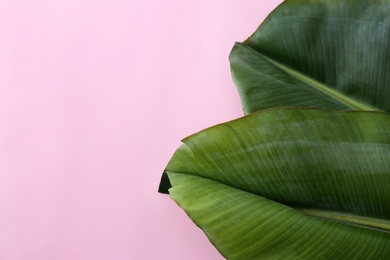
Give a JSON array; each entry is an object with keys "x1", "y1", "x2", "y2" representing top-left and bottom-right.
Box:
[{"x1": 160, "y1": 108, "x2": 390, "y2": 259}]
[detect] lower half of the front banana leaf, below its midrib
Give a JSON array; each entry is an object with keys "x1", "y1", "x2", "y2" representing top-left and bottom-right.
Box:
[{"x1": 169, "y1": 173, "x2": 390, "y2": 259}]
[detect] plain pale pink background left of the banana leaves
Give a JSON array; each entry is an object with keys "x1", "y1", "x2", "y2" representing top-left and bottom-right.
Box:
[{"x1": 0, "y1": 0, "x2": 281, "y2": 260}]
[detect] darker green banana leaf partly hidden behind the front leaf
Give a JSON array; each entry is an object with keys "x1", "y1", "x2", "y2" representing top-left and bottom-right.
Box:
[{"x1": 230, "y1": 0, "x2": 390, "y2": 114}]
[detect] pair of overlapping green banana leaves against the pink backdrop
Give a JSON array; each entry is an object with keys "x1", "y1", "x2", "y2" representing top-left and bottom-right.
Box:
[{"x1": 159, "y1": 0, "x2": 390, "y2": 259}]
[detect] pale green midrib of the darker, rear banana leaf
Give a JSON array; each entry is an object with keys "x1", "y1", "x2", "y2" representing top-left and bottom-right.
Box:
[{"x1": 244, "y1": 43, "x2": 382, "y2": 111}]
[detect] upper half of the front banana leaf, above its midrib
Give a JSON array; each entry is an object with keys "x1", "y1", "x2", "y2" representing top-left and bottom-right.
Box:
[{"x1": 166, "y1": 108, "x2": 390, "y2": 219}]
